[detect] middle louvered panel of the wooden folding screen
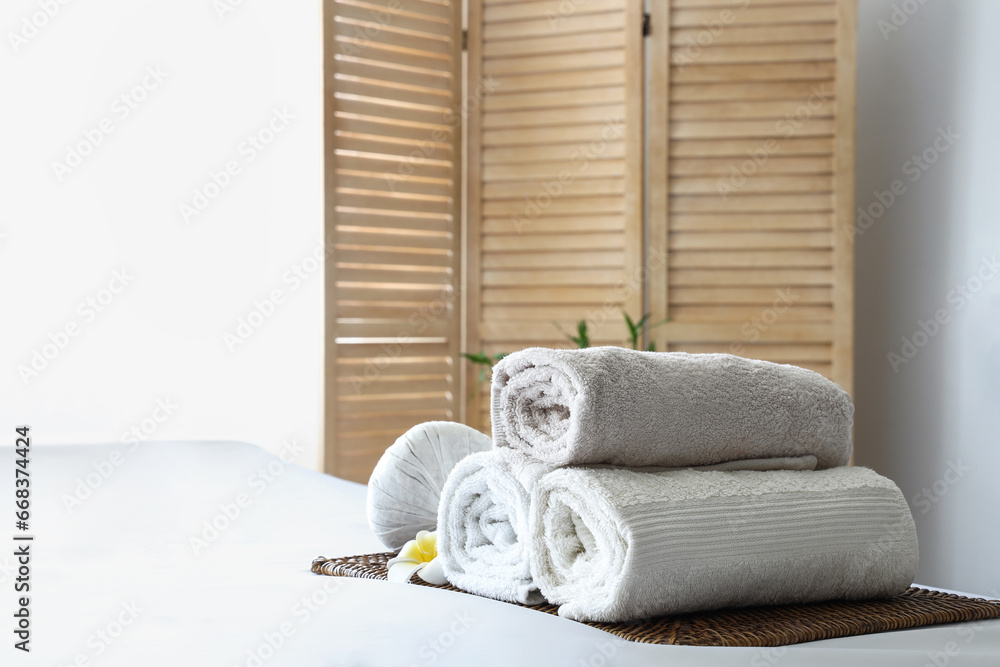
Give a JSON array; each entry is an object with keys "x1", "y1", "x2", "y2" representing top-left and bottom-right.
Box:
[{"x1": 467, "y1": 0, "x2": 644, "y2": 429}]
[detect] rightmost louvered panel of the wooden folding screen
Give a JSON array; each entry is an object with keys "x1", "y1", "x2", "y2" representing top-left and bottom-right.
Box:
[{"x1": 650, "y1": 0, "x2": 854, "y2": 390}]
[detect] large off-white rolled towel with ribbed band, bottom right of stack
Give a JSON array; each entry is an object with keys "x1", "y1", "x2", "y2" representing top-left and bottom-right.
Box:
[{"x1": 530, "y1": 467, "x2": 918, "y2": 622}]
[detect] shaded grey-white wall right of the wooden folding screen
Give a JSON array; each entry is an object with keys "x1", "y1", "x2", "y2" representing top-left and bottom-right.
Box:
[{"x1": 855, "y1": 0, "x2": 1000, "y2": 594}]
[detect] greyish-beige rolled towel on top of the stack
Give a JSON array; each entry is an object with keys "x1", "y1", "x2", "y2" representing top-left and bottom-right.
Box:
[{"x1": 491, "y1": 347, "x2": 854, "y2": 469}]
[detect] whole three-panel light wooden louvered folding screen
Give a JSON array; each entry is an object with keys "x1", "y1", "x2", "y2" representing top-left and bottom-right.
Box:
[{"x1": 325, "y1": 0, "x2": 856, "y2": 481}]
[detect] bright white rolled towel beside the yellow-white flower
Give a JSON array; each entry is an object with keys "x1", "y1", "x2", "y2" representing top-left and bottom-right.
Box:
[{"x1": 437, "y1": 449, "x2": 549, "y2": 604}]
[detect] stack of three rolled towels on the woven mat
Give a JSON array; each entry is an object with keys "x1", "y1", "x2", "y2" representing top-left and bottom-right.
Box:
[{"x1": 437, "y1": 347, "x2": 917, "y2": 622}]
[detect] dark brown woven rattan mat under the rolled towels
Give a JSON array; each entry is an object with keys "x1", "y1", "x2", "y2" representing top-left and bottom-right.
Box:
[{"x1": 312, "y1": 553, "x2": 1000, "y2": 646}]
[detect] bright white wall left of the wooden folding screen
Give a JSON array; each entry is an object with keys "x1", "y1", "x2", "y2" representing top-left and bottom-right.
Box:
[{"x1": 0, "y1": 0, "x2": 323, "y2": 467}]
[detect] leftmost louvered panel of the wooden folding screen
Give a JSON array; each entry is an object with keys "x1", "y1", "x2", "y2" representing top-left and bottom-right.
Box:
[{"x1": 325, "y1": 0, "x2": 461, "y2": 481}]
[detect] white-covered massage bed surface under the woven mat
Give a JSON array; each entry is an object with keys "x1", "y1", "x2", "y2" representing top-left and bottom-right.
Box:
[{"x1": 0, "y1": 442, "x2": 1000, "y2": 667}]
